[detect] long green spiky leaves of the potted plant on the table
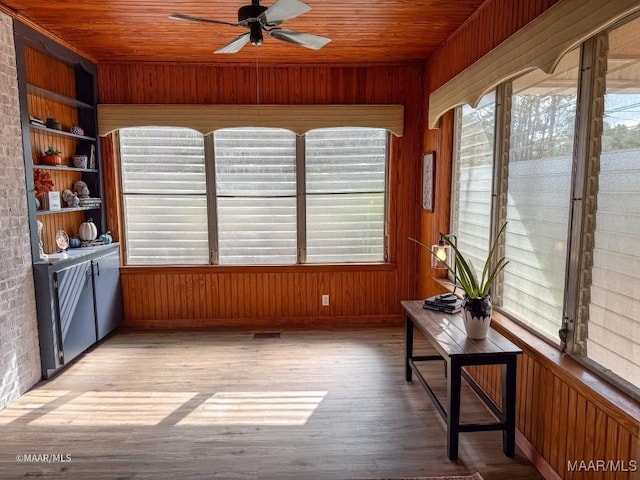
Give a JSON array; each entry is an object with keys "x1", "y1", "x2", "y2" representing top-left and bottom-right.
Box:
[{"x1": 409, "y1": 223, "x2": 509, "y2": 298}]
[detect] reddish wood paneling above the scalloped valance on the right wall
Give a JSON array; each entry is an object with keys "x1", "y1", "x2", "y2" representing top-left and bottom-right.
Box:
[{"x1": 427, "y1": 0, "x2": 558, "y2": 93}]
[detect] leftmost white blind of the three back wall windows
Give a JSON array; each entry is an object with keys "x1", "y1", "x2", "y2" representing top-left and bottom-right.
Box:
[{"x1": 120, "y1": 127, "x2": 209, "y2": 265}]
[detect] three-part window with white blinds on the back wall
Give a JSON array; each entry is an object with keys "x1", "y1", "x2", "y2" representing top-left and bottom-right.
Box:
[{"x1": 120, "y1": 127, "x2": 388, "y2": 265}]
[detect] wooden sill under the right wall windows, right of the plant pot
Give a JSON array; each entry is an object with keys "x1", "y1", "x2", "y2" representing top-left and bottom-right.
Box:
[{"x1": 438, "y1": 281, "x2": 640, "y2": 435}]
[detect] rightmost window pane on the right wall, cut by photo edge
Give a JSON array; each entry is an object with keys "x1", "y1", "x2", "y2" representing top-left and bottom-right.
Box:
[{"x1": 587, "y1": 20, "x2": 640, "y2": 387}]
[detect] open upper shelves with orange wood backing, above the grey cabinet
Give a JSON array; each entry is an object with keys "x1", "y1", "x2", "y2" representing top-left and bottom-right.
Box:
[{"x1": 14, "y1": 22, "x2": 107, "y2": 256}]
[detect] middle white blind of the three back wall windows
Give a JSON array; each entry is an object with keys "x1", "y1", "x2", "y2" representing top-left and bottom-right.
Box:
[{"x1": 214, "y1": 128, "x2": 297, "y2": 265}]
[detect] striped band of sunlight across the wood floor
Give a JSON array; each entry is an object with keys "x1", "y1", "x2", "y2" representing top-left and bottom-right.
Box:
[{"x1": 0, "y1": 390, "x2": 327, "y2": 427}]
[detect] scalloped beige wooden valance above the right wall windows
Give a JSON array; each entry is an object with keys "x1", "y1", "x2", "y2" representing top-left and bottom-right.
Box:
[{"x1": 429, "y1": 0, "x2": 640, "y2": 128}]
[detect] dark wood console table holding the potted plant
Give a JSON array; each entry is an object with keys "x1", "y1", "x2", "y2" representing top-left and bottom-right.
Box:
[{"x1": 402, "y1": 300, "x2": 522, "y2": 460}]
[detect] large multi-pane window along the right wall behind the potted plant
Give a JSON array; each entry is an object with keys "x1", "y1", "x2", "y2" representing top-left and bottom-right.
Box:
[{"x1": 452, "y1": 18, "x2": 640, "y2": 398}]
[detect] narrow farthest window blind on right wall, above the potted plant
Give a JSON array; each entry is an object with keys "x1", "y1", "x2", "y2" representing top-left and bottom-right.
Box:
[{"x1": 453, "y1": 92, "x2": 495, "y2": 275}]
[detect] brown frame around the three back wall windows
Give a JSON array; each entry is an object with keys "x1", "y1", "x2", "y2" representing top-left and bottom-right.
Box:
[{"x1": 119, "y1": 126, "x2": 392, "y2": 267}]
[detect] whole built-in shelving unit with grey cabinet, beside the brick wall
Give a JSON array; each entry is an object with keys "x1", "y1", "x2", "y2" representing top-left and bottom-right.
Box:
[{"x1": 14, "y1": 21, "x2": 122, "y2": 378}]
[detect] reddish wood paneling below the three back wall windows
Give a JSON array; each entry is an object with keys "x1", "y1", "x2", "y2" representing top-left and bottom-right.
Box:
[{"x1": 122, "y1": 265, "x2": 398, "y2": 328}]
